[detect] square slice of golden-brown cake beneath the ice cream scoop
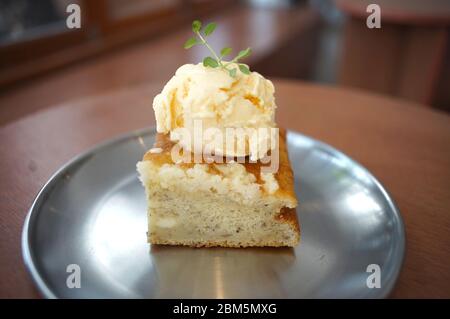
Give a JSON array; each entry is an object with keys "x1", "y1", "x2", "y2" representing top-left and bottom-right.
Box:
[{"x1": 137, "y1": 131, "x2": 300, "y2": 247}]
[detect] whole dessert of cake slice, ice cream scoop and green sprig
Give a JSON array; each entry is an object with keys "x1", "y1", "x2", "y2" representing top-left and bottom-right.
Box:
[{"x1": 137, "y1": 21, "x2": 300, "y2": 247}]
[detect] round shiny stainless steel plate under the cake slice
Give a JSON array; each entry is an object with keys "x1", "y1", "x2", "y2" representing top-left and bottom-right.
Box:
[{"x1": 22, "y1": 130, "x2": 405, "y2": 298}]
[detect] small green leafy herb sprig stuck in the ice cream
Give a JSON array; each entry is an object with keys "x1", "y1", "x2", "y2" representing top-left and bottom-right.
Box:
[{"x1": 184, "y1": 20, "x2": 252, "y2": 78}]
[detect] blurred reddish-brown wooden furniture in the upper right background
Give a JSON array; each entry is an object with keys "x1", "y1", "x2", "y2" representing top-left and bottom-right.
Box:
[{"x1": 335, "y1": 0, "x2": 450, "y2": 110}]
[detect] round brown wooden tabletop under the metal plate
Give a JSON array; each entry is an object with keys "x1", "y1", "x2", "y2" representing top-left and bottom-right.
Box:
[{"x1": 0, "y1": 80, "x2": 450, "y2": 298}]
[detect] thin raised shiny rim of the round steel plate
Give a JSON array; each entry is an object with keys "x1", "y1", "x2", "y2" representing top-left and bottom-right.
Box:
[{"x1": 21, "y1": 126, "x2": 406, "y2": 299}]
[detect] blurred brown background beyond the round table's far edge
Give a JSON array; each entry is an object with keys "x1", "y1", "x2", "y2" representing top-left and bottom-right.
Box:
[{"x1": 0, "y1": 0, "x2": 450, "y2": 125}]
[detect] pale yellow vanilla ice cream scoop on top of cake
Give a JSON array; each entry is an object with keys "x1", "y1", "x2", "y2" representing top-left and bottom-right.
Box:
[{"x1": 153, "y1": 63, "x2": 276, "y2": 160}]
